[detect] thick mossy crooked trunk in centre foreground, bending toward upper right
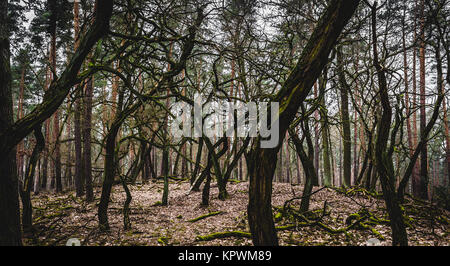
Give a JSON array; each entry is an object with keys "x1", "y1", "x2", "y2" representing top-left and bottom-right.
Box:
[{"x1": 247, "y1": 0, "x2": 359, "y2": 245}]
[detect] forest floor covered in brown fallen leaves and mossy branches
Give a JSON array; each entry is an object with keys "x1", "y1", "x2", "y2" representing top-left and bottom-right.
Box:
[{"x1": 24, "y1": 181, "x2": 450, "y2": 246}]
